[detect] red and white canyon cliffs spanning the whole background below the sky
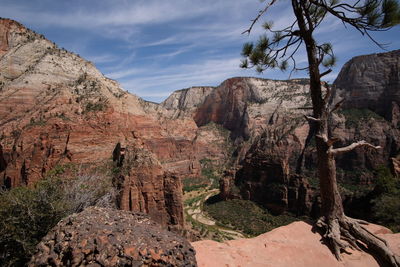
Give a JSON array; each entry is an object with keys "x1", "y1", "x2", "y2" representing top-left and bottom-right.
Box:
[{"x1": 0, "y1": 19, "x2": 400, "y2": 266}]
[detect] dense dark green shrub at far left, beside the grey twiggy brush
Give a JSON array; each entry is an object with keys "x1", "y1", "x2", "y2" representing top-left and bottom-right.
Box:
[{"x1": 0, "y1": 180, "x2": 68, "y2": 266}]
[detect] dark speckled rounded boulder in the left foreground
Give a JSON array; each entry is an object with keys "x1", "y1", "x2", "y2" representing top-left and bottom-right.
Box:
[{"x1": 29, "y1": 207, "x2": 197, "y2": 267}]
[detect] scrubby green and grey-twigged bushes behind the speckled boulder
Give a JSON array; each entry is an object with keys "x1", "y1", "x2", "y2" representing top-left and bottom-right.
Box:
[{"x1": 0, "y1": 166, "x2": 117, "y2": 266}]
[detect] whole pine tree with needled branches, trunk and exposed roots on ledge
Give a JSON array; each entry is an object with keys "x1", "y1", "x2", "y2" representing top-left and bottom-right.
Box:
[{"x1": 242, "y1": 0, "x2": 400, "y2": 266}]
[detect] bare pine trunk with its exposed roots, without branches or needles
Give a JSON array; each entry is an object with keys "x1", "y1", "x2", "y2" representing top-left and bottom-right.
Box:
[{"x1": 292, "y1": 0, "x2": 400, "y2": 267}]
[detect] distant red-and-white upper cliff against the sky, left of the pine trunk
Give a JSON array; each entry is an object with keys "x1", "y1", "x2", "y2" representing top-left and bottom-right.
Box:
[{"x1": 194, "y1": 77, "x2": 308, "y2": 140}]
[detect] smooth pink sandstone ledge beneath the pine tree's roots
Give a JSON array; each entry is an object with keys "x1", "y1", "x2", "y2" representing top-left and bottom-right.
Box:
[{"x1": 192, "y1": 222, "x2": 400, "y2": 267}]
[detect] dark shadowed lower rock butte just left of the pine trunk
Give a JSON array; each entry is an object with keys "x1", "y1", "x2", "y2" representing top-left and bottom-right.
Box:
[{"x1": 220, "y1": 135, "x2": 315, "y2": 215}]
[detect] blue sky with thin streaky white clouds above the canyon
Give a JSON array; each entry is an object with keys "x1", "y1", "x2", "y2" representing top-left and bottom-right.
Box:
[{"x1": 0, "y1": 0, "x2": 400, "y2": 102}]
